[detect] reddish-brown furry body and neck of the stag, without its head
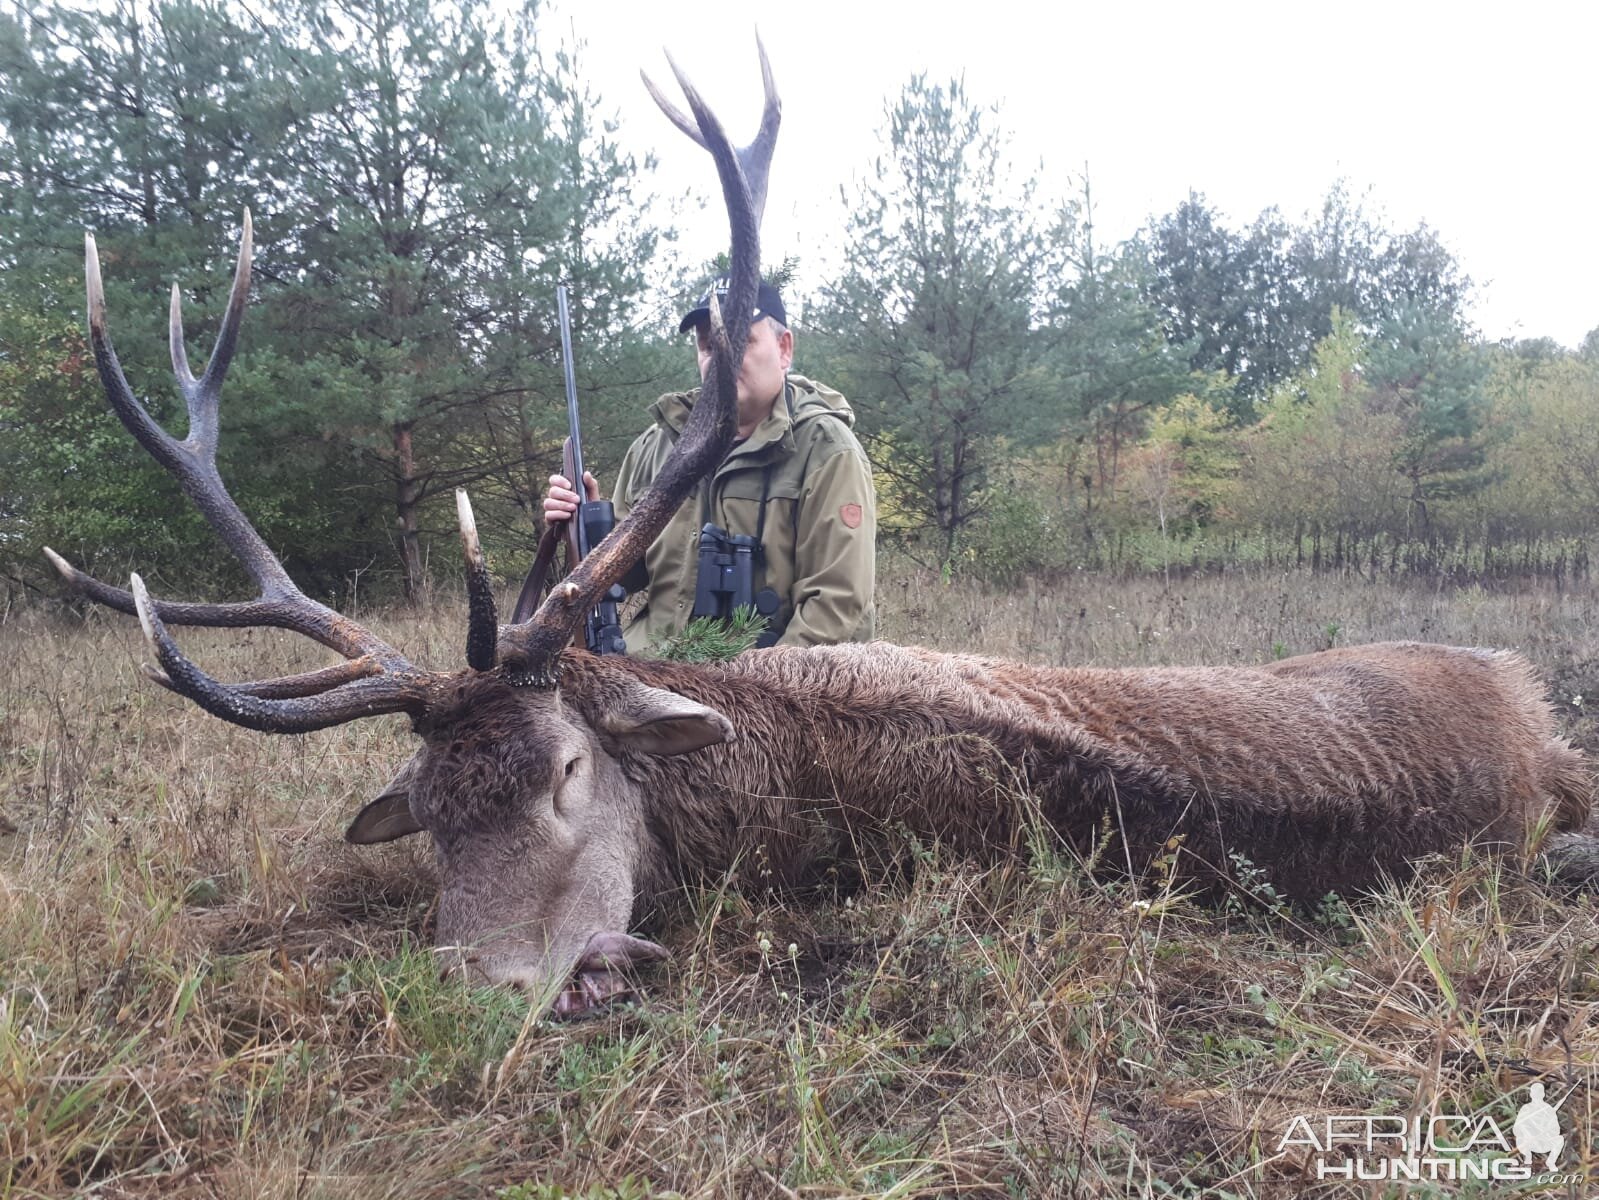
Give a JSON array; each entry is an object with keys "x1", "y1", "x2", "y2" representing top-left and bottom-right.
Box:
[{"x1": 563, "y1": 643, "x2": 1589, "y2": 901}]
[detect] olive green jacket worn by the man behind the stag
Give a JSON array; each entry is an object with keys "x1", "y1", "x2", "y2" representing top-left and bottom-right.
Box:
[{"x1": 612, "y1": 374, "x2": 878, "y2": 654}]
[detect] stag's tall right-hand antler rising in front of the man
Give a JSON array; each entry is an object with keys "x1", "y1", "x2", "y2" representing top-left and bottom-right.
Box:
[{"x1": 499, "y1": 38, "x2": 782, "y2": 688}]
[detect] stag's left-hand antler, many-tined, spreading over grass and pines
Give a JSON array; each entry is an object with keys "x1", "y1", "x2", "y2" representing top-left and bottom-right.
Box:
[{"x1": 45, "y1": 210, "x2": 435, "y2": 733}]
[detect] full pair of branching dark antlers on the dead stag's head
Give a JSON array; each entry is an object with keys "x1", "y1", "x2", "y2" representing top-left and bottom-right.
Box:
[{"x1": 59, "y1": 38, "x2": 780, "y2": 713}]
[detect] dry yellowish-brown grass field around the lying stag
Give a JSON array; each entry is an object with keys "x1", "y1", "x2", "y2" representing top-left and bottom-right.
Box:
[{"x1": 0, "y1": 576, "x2": 1599, "y2": 1200}]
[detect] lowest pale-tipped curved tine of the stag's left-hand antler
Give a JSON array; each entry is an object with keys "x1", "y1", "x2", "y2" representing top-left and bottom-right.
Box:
[{"x1": 131, "y1": 574, "x2": 432, "y2": 733}]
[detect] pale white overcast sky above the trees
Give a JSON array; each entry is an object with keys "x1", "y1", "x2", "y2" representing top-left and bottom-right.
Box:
[{"x1": 545, "y1": 0, "x2": 1599, "y2": 346}]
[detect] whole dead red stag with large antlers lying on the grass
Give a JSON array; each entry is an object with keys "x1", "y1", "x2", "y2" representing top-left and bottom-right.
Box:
[{"x1": 51, "y1": 42, "x2": 1591, "y2": 1011}]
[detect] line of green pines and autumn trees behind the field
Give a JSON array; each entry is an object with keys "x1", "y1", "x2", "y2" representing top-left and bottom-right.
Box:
[{"x1": 0, "y1": 0, "x2": 1599, "y2": 602}]
